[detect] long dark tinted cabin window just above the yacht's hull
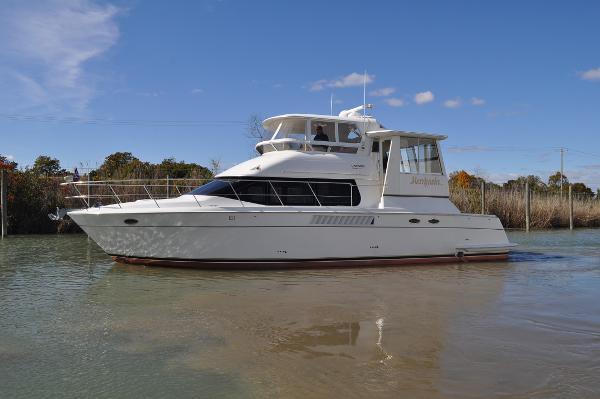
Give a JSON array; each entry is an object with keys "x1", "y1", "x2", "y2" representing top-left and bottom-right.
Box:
[{"x1": 189, "y1": 179, "x2": 360, "y2": 206}]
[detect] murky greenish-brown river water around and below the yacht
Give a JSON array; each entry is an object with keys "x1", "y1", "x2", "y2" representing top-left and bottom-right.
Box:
[{"x1": 0, "y1": 230, "x2": 600, "y2": 398}]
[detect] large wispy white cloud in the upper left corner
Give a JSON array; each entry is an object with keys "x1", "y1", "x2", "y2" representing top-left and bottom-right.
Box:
[{"x1": 0, "y1": 0, "x2": 120, "y2": 110}]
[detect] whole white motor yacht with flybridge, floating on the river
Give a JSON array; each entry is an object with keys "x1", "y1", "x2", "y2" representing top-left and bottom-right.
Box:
[{"x1": 68, "y1": 106, "x2": 514, "y2": 269}]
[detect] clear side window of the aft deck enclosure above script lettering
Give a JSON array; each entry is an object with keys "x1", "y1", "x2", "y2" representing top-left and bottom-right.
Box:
[{"x1": 400, "y1": 137, "x2": 442, "y2": 173}]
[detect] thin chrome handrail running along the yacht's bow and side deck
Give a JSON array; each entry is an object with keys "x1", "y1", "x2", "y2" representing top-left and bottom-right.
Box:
[{"x1": 61, "y1": 178, "x2": 356, "y2": 208}]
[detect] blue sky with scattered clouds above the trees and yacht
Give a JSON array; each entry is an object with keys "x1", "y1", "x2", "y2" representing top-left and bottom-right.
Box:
[{"x1": 0, "y1": 0, "x2": 600, "y2": 188}]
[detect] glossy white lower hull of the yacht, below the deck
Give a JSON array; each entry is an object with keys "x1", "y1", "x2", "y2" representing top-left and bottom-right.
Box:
[{"x1": 70, "y1": 208, "x2": 511, "y2": 268}]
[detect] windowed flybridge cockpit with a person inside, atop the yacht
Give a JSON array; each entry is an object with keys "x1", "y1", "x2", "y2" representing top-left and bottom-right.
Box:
[{"x1": 256, "y1": 115, "x2": 378, "y2": 154}]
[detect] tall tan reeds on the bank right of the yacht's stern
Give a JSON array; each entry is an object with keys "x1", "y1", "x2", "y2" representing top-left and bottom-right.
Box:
[{"x1": 450, "y1": 188, "x2": 600, "y2": 229}]
